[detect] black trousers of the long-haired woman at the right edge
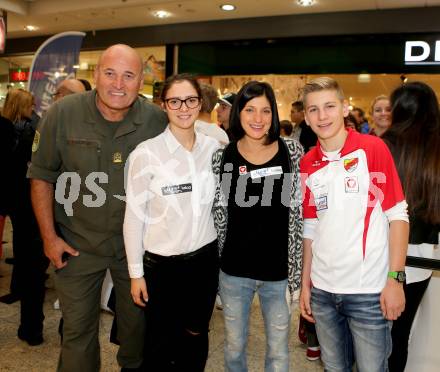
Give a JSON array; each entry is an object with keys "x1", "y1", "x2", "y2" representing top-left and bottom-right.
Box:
[{"x1": 388, "y1": 277, "x2": 431, "y2": 372}]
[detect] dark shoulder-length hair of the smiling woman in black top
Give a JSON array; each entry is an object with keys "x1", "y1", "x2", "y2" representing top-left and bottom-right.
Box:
[{"x1": 229, "y1": 81, "x2": 280, "y2": 144}]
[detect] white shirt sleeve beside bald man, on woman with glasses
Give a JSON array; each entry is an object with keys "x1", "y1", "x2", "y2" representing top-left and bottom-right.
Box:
[{"x1": 123, "y1": 147, "x2": 150, "y2": 278}]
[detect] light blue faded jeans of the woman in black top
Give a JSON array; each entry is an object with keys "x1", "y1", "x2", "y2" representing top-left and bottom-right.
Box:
[{"x1": 220, "y1": 271, "x2": 290, "y2": 372}]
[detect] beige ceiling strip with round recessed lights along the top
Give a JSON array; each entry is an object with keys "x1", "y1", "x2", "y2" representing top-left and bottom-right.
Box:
[{"x1": 5, "y1": 0, "x2": 440, "y2": 38}]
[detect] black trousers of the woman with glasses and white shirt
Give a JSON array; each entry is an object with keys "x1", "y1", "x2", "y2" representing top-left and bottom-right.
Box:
[{"x1": 144, "y1": 241, "x2": 219, "y2": 372}]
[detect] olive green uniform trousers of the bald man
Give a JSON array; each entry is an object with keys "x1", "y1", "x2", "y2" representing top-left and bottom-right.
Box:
[{"x1": 55, "y1": 250, "x2": 145, "y2": 372}]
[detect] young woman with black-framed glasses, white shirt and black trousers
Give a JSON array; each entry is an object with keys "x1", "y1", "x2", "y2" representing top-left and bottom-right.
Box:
[{"x1": 124, "y1": 74, "x2": 220, "y2": 372}]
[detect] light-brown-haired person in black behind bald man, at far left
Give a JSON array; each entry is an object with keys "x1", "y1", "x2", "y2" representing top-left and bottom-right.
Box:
[{"x1": 2, "y1": 89, "x2": 49, "y2": 346}]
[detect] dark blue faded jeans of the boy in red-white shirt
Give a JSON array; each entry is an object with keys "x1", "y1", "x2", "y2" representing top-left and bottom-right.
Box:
[{"x1": 311, "y1": 288, "x2": 391, "y2": 372}]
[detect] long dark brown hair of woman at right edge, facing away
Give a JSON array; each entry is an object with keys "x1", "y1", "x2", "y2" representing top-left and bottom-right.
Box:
[{"x1": 383, "y1": 82, "x2": 440, "y2": 224}]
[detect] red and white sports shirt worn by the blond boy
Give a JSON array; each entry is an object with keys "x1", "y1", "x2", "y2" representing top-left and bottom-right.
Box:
[{"x1": 301, "y1": 130, "x2": 408, "y2": 294}]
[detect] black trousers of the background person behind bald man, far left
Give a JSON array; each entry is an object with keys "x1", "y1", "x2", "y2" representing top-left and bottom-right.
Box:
[{"x1": 9, "y1": 205, "x2": 49, "y2": 334}]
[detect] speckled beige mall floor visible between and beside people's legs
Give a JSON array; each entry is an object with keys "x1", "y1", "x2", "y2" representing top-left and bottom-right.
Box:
[{"x1": 0, "y1": 217, "x2": 323, "y2": 372}]
